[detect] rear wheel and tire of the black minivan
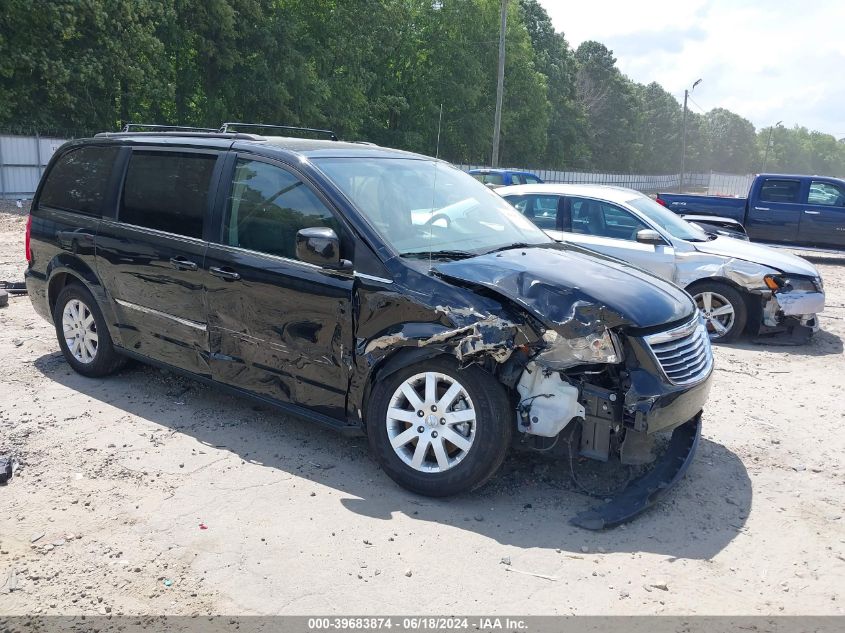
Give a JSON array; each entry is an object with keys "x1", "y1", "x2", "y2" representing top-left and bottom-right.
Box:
[{"x1": 53, "y1": 284, "x2": 126, "y2": 378}]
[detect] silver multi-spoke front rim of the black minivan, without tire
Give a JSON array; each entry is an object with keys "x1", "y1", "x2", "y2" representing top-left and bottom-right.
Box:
[{"x1": 385, "y1": 371, "x2": 476, "y2": 473}]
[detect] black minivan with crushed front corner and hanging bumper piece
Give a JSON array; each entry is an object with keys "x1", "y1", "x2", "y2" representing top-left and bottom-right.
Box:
[{"x1": 26, "y1": 126, "x2": 713, "y2": 527}]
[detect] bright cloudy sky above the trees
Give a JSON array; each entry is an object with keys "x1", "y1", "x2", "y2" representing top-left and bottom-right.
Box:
[{"x1": 540, "y1": 0, "x2": 845, "y2": 138}]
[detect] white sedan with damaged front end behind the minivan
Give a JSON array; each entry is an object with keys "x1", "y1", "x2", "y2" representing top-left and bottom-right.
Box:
[{"x1": 496, "y1": 184, "x2": 824, "y2": 341}]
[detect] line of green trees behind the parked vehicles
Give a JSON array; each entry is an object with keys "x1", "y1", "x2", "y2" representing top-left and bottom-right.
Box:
[{"x1": 0, "y1": 0, "x2": 845, "y2": 176}]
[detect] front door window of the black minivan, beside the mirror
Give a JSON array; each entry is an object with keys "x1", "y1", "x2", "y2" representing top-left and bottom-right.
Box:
[{"x1": 223, "y1": 159, "x2": 340, "y2": 259}]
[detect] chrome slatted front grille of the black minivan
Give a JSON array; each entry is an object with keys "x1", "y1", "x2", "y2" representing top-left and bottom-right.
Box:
[{"x1": 645, "y1": 316, "x2": 713, "y2": 385}]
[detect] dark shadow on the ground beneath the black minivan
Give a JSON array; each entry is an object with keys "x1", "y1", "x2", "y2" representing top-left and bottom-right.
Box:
[{"x1": 35, "y1": 352, "x2": 752, "y2": 559}]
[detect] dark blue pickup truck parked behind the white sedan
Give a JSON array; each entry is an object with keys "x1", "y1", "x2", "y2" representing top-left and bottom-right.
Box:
[{"x1": 657, "y1": 174, "x2": 845, "y2": 248}]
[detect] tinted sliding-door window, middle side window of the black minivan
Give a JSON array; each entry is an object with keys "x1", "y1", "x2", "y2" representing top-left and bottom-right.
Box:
[{"x1": 118, "y1": 152, "x2": 217, "y2": 237}]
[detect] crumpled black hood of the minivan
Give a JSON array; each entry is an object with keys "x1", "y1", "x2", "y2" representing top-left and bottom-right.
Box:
[{"x1": 434, "y1": 244, "x2": 696, "y2": 338}]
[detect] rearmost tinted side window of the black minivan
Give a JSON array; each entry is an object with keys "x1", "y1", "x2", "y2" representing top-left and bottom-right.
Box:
[{"x1": 40, "y1": 146, "x2": 118, "y2": 214}]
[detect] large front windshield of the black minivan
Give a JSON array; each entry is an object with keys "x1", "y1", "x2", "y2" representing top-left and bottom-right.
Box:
[{"x1": 312, "y1": 156, "x2": 553, "y2": 257}]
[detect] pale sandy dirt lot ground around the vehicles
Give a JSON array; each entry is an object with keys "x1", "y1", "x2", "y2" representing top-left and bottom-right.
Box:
[{"x1": 0, "y1": 201, "x2": 845, "y2": 614}]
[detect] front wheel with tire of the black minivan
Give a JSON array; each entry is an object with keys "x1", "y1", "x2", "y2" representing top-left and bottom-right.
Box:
[{"x1": 367, "y1": 356, "x2": 514, "y2": 497}]
